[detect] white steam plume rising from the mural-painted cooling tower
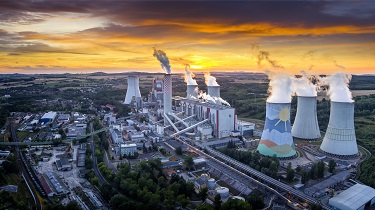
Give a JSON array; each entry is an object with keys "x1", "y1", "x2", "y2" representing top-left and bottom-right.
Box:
[{"x1": 266, "y1": 71, "x2": 293, "y2": 103}]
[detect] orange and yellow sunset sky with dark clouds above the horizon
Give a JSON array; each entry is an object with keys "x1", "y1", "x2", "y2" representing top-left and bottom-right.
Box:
[{"x1": 0, "y1": 0, "x2": 375, "y2": 74}]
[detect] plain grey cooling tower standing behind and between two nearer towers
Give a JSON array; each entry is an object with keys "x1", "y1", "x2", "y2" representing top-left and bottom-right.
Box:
[{"x1": 292, "y1": 96, "x2": 320, "y2": 140}]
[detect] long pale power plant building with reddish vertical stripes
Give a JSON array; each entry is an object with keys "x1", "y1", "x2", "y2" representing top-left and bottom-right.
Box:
[{"x1": 181, "y1": 99, "x2": 237, "y2": 138}]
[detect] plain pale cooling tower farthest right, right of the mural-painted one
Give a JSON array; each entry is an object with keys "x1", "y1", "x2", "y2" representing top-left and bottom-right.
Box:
[{"x1": 320, "y1": 101, "x2": 358, "y2": 156}]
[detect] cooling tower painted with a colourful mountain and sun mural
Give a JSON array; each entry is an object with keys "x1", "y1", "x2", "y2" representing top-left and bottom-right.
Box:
[{"x1": 257, "y1": 102, "x2": 296, "y2": 158}]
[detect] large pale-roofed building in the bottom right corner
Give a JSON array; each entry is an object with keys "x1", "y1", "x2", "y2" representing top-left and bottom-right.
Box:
[{"x1": 329, "y1": 184, "x2": 375, "y2": 210}]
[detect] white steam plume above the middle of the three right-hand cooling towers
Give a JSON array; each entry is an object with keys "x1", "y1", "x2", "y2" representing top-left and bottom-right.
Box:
[{"x1": 293, "y1": 71, "x2": 317, "y2": 96}]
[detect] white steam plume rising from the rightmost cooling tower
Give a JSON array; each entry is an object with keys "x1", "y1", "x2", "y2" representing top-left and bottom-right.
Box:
[{"x1": 322, "y1": 72, "x2": 354, "y2": 102}]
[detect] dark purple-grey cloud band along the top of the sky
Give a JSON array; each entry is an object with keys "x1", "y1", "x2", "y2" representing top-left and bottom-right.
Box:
[{"x1": 0, "y1": 1, "x2": 375, "y2": 27}]
